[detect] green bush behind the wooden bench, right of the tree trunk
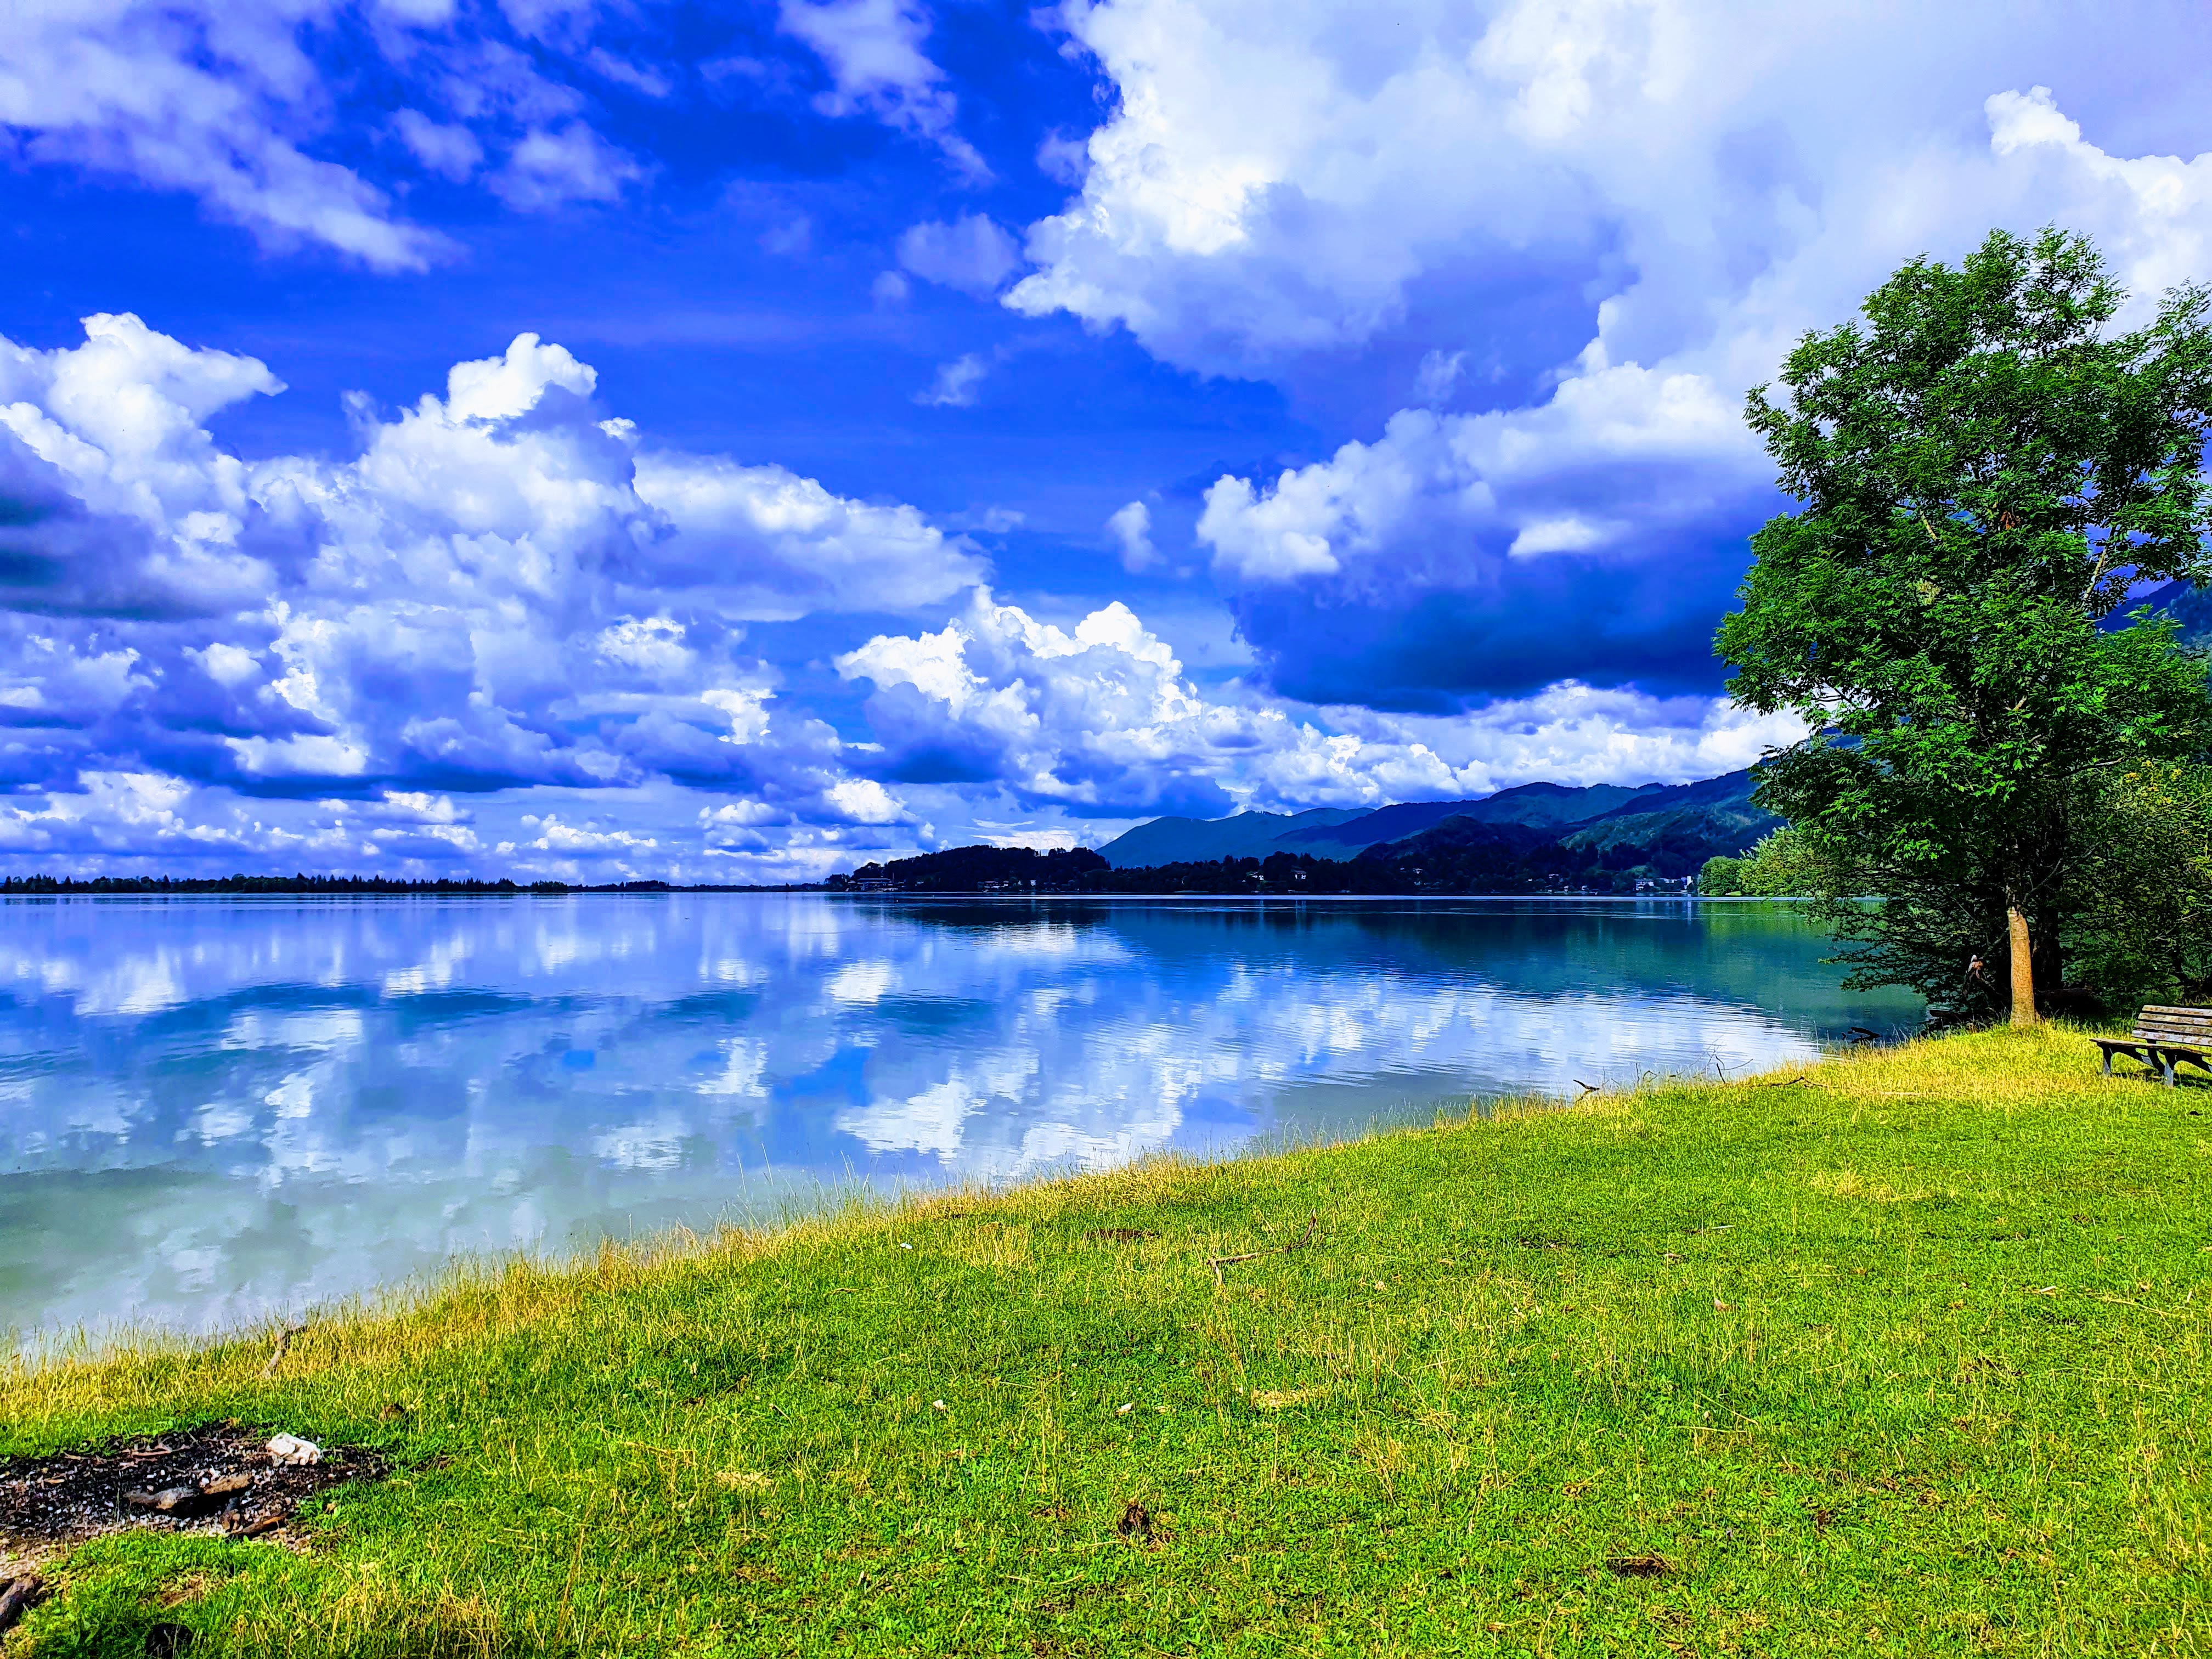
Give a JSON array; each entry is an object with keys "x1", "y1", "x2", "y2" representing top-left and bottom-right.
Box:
[{"x1": 2066, "y1": 765, "x2": 2212, "y2": 1007}]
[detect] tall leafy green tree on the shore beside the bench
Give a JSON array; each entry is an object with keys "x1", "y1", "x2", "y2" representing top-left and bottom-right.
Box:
[{"x1": 1717, "y1": 230, "x2": 2212, "y2": 1022}]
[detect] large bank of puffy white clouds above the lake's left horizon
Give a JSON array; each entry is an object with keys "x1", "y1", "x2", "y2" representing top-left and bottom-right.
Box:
[{"x1": 0, "y1": 317, "x2": 986, "y2": 876}]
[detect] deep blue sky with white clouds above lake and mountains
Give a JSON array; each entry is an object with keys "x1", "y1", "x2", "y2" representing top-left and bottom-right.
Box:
[{"x1": 0, "y1": 0, "x2": 2212, "y2": 881}]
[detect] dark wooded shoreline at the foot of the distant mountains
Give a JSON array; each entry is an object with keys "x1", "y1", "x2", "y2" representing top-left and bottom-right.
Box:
[{"x1": 825, "y1": 825, "x2": 1697, "y2": 894}]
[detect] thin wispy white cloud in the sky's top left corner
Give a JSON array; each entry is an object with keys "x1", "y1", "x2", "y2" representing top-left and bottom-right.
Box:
[{"x1": 0, "y1": 0, "x2": 641, "y2": 272}]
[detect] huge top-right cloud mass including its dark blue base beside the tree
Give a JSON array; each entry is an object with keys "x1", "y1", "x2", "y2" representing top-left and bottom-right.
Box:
[{"x1": 1005, "y1": 0, "x2": 2212, "y2": 708}]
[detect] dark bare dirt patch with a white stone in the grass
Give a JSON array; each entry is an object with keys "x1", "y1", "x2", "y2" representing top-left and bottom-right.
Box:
[{"x1": 0, "y1": 1423, "x2": 392, "y2": 1546}]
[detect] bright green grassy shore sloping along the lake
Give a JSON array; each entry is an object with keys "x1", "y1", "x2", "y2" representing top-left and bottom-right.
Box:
[{"x1": 0, "y1": 1031, "x2": 2212, "y2": 1655}]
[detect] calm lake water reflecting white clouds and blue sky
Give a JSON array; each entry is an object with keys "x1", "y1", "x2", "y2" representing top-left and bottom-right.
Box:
[{"x1": 0, "y1": 894, "x2": 1920, "y2": 1340}]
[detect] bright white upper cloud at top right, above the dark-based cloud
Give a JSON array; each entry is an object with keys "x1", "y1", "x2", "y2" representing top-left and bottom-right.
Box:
[{"x1": 1009, "y1": 0, "x2": 2203, "y2": 371}]
